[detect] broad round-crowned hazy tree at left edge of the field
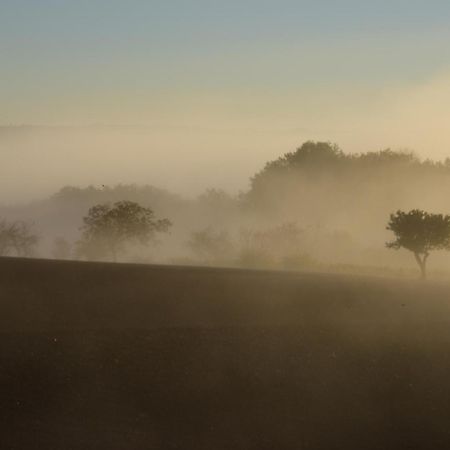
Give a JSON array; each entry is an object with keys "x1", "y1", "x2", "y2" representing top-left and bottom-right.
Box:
[{"x1": 78, "y1": 201, "x2": 171, "y2": 261}]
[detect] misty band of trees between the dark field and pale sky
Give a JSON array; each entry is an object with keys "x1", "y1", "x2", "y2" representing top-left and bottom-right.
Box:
[{"x1": 0, "y1": 142, "x2": 450, "y2": 276}]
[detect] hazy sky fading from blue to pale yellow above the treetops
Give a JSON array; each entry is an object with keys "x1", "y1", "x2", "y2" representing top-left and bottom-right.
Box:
[{"x1": 0, "y1": 0, "x2": 450, "y2": 200}]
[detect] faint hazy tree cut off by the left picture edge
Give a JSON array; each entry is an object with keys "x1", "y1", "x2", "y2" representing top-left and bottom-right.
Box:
[{"x1": 0, "y1": 221, "x2": 39, "y2": 256}]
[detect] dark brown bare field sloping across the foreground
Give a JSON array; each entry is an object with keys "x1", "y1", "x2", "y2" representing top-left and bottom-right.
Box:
[{"x1": 0, "y1": 259, "x2": 450, "y2": 450}]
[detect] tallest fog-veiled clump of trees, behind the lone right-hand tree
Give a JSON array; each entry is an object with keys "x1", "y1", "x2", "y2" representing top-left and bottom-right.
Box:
[{"x1": 241, "y1": 142, "x2": 450, "y2": 248}]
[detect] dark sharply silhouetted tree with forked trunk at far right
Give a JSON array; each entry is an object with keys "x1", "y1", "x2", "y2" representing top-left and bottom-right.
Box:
[{"x1": 386, "y1": 209, "x2": 450, "y2": 278}]
